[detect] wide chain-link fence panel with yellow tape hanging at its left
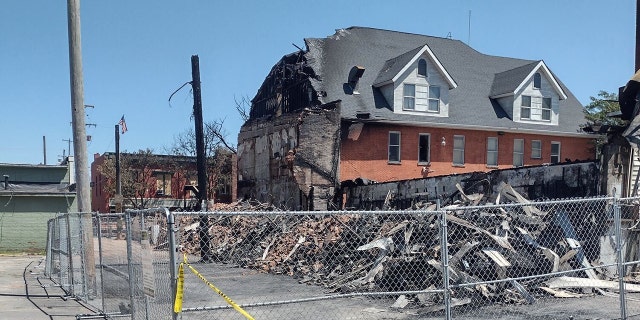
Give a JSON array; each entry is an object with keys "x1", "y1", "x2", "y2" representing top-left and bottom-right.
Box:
[{"x1": 175, "y1": 211, "x2": 445, "y2": 319}]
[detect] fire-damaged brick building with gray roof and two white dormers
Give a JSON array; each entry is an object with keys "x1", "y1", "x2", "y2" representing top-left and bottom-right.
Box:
[{"x1": 238, "y1": 27, "x2": 595, "y2": 209}]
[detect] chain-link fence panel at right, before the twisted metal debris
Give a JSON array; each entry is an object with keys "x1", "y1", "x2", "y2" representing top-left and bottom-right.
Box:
[{"x1": 443, "y1": 197, "x2": 636, "y2": 319}]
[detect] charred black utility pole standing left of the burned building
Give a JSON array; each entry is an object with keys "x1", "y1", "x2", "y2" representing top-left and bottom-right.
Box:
[{"x1": 191, "y1": 55, "x2": 211, "y2": 262}]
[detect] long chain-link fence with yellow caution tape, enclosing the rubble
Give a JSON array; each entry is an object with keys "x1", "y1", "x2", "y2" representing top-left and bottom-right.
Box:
[{"x1": 48, "y1": 197, "x2": 640, "y2": 319}]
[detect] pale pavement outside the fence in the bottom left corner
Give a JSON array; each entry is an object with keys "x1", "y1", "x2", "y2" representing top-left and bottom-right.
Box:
[{"x1": 0, "y1": 255, "x2": 95, "y2": 320}]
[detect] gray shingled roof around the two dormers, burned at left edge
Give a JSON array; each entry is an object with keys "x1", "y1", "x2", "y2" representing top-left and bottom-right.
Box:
[{"x1": 305, "y1": 27, "x2": 586, "y2": 134}]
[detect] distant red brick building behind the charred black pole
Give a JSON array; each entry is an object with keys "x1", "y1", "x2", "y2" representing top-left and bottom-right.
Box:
[{"x1": 91, "y1": 152, "x2": 237, "y2": 212}]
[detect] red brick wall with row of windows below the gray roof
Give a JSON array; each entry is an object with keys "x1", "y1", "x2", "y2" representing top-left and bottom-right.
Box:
[{"x1": 340, "y1": 125, "x2": 595, "y2": 182}]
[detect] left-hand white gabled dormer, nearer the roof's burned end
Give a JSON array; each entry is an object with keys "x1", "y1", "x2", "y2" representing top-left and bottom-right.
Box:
[{"x1": 373, "y1": 45, "x2": 458, "y2": 117}]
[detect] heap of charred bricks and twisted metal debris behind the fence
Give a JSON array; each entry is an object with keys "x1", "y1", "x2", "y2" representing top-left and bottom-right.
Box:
[{"x1": 170, "y1": 185, "x2": 640, "y2": 310}]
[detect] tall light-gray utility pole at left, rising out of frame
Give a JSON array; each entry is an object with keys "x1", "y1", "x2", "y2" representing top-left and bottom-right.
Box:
[{"x1": 67, "y1": 0, "x2": 96, "y2": 297}]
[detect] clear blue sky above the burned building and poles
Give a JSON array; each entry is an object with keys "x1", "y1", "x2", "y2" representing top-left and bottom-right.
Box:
[{"x1": 0, "y1": 0, "x2": 635, "y2": 164}]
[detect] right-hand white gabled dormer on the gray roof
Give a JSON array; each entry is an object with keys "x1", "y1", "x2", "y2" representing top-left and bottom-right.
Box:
[{"x1": 490, "y1": 61, "x2": 567, "y2": 125}]
